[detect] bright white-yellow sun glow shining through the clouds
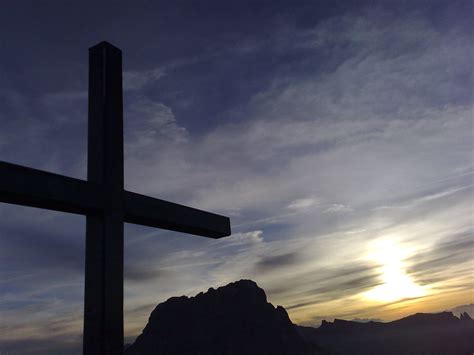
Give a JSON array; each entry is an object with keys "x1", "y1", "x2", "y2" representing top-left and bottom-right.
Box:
[{"x1": 364, "y1": 240, "x2": 427, "y2": 302}]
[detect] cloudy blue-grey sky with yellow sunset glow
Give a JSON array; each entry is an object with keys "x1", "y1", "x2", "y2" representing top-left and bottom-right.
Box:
[{"x1": 0, "y1": 0, "x2": 474, "y2": 354}]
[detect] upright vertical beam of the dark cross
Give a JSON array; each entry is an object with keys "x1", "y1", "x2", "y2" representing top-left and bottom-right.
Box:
[{"x1": 83, "y1": 42, "x2": 124, "y2": 355}]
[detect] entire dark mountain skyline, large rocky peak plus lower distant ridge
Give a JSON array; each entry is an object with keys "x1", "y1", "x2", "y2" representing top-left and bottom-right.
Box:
[{"x1": 125, "y1": 280, "x2": 474, "y2": 355}]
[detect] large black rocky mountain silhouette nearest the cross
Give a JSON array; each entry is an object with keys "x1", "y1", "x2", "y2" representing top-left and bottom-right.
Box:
[{"x1": 125, "y1": 280, "x2": 316, "y2": 355}]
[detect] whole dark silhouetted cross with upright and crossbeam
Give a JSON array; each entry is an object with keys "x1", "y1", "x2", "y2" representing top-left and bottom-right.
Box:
[{"x1": 0, "y1": 42, "x2": 231, "y2": 355}]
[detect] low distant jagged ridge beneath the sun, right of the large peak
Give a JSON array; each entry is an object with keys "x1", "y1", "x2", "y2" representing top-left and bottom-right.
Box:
[{"x1": 300, "y1": 312, "x2": 474, "y2": 355}]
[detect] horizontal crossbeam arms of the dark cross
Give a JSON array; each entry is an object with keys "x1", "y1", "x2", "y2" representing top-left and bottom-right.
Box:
[{"x1": 0, "y1": 161, "x2": 231, "y2": 238}]
